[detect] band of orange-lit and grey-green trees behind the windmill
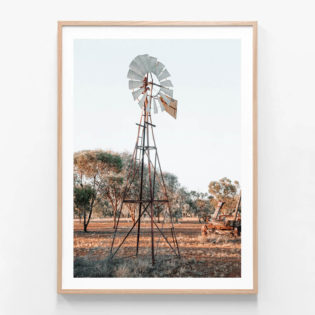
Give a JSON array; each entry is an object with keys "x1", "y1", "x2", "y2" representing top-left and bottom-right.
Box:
[{"x1": 73, "y1": 150, "x2": 239, "y2": 231}]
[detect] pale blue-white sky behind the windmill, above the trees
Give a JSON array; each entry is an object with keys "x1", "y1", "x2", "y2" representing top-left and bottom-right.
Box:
[{"x1": 73, "y1": 39, "x2": 241, "y2": 192}]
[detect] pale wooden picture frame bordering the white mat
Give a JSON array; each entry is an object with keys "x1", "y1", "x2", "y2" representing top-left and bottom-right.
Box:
[{"x1": 57, "y1": 21, "x2": 258, "y2": 294}]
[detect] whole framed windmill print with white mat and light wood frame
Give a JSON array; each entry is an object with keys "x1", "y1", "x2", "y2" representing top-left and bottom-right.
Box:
[{"x1": 57, "y1": 21, "x2": 258, "y2": 294}]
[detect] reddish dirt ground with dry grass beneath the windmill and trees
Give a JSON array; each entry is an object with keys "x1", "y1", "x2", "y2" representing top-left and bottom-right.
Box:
[{"x1": 74, "y1": 220, "x2": 241, "y2": 277}]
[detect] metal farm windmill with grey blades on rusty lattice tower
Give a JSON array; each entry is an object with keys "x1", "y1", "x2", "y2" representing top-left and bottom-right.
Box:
[{"x1": 110, "y1": 54, "x2": 180, "y2": 264}]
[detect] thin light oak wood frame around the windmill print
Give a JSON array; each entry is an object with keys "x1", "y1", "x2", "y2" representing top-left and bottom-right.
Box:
[{"x1": 57, "y1": 21, "x2": 258, "y2": 295}]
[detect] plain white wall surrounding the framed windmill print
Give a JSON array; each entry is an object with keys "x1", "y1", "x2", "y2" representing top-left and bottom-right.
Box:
[{"x1": 0, "y1": 0, "x2": 315, "y2": 315}]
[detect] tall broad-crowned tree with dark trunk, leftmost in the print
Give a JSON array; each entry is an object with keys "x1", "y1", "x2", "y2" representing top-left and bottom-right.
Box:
[{"x1": 74, "y1": 150, "x2": 122, "y2": 232}]
